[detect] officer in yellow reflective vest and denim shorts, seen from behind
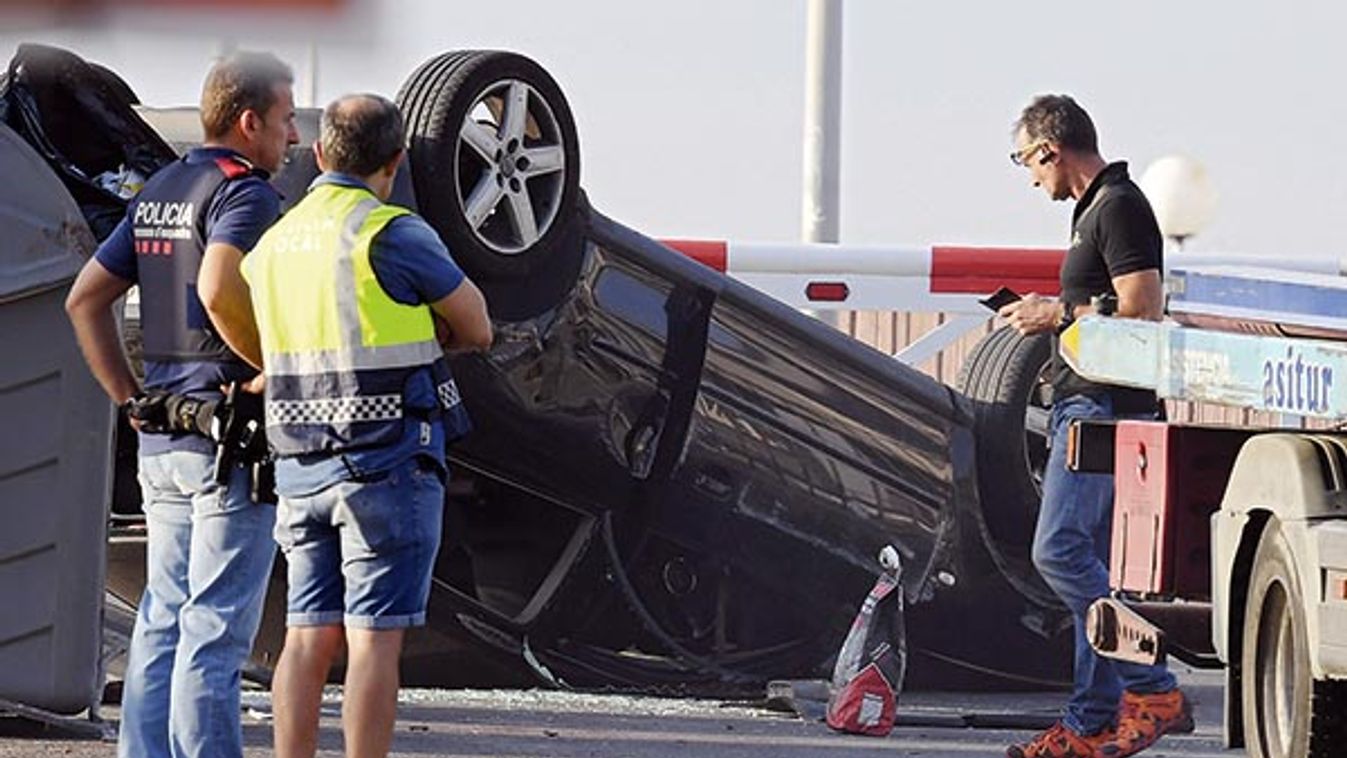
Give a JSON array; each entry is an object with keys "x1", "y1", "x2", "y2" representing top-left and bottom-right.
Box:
[{"x1": 234, "y1": 96, "x2": 492, "y2": 758}]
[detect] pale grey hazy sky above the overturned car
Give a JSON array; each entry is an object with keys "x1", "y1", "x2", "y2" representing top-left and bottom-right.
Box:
[{"x1": 0, "y1": 0, "x2": 1347, "y2": 257}]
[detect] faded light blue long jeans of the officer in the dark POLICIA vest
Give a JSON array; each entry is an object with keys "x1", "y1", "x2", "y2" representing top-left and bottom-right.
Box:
[{"x1": 117, "y1": 451, "x2": 276, "y2": 758}]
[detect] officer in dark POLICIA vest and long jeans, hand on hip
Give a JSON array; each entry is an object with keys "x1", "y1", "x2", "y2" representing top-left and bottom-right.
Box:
[{"x1": 66, "y1": 53, "x2": 298, "y2": 758}]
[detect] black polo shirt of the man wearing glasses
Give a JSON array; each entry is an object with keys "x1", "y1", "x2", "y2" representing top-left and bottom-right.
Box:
[{"x1": 1052, "y1": 162, "x2": 1164, "y2": 413}]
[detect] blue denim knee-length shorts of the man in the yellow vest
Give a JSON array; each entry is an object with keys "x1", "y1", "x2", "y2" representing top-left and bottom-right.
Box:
[{"x1": 276, "y1": 456, "x2": 445, "y2": 629}]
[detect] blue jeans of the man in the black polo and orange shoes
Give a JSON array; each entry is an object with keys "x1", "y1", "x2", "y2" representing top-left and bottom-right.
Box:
[{"x1": 1033, "y1": 394, "x2": 1175, "y2": 734}]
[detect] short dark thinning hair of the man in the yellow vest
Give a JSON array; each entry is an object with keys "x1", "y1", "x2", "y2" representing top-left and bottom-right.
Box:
[{"x1": 318, "y1": 94, "x2": 407, "y2": 176}]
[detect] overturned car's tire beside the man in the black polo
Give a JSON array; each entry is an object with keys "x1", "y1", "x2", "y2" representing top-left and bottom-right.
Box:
[{"x1": 955, "y1": 326, "x2": 1061, "y2": 607}]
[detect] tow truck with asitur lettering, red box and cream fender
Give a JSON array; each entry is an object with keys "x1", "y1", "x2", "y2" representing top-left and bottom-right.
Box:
[{"x1": 1060, "y1": 265, "x2": 1347, "y2": 758}]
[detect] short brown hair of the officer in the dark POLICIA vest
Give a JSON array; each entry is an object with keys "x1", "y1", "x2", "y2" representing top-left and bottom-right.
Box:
[{"x1": 201, "y1": 51, "x2": 295, "y2": 140}]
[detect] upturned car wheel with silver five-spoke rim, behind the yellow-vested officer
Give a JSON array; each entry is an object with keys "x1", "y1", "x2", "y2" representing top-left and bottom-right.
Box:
[{"x1": 397, "y1": 51, "x2": 582, "y2": 315}]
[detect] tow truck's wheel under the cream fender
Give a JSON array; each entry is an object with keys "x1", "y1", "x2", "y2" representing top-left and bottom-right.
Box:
[{"x1": 1241, "y1": 518, "x2": 1347, "y2": 758}]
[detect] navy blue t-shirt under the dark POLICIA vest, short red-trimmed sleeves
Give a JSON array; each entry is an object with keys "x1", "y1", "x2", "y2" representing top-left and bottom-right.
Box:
[{"x1": 94, "y1": 147, "x2": 280, "y2": 455}]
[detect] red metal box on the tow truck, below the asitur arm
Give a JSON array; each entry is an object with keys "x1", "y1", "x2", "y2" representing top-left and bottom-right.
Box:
[{"x1": 1110, "y1": 421, "x2": 1253, "y2": 599}]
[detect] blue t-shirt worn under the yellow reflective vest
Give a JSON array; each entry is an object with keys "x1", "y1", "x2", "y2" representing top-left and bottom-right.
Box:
[{"x1": 268, "y1": 172, "x2": 465, "y2": 497}]
